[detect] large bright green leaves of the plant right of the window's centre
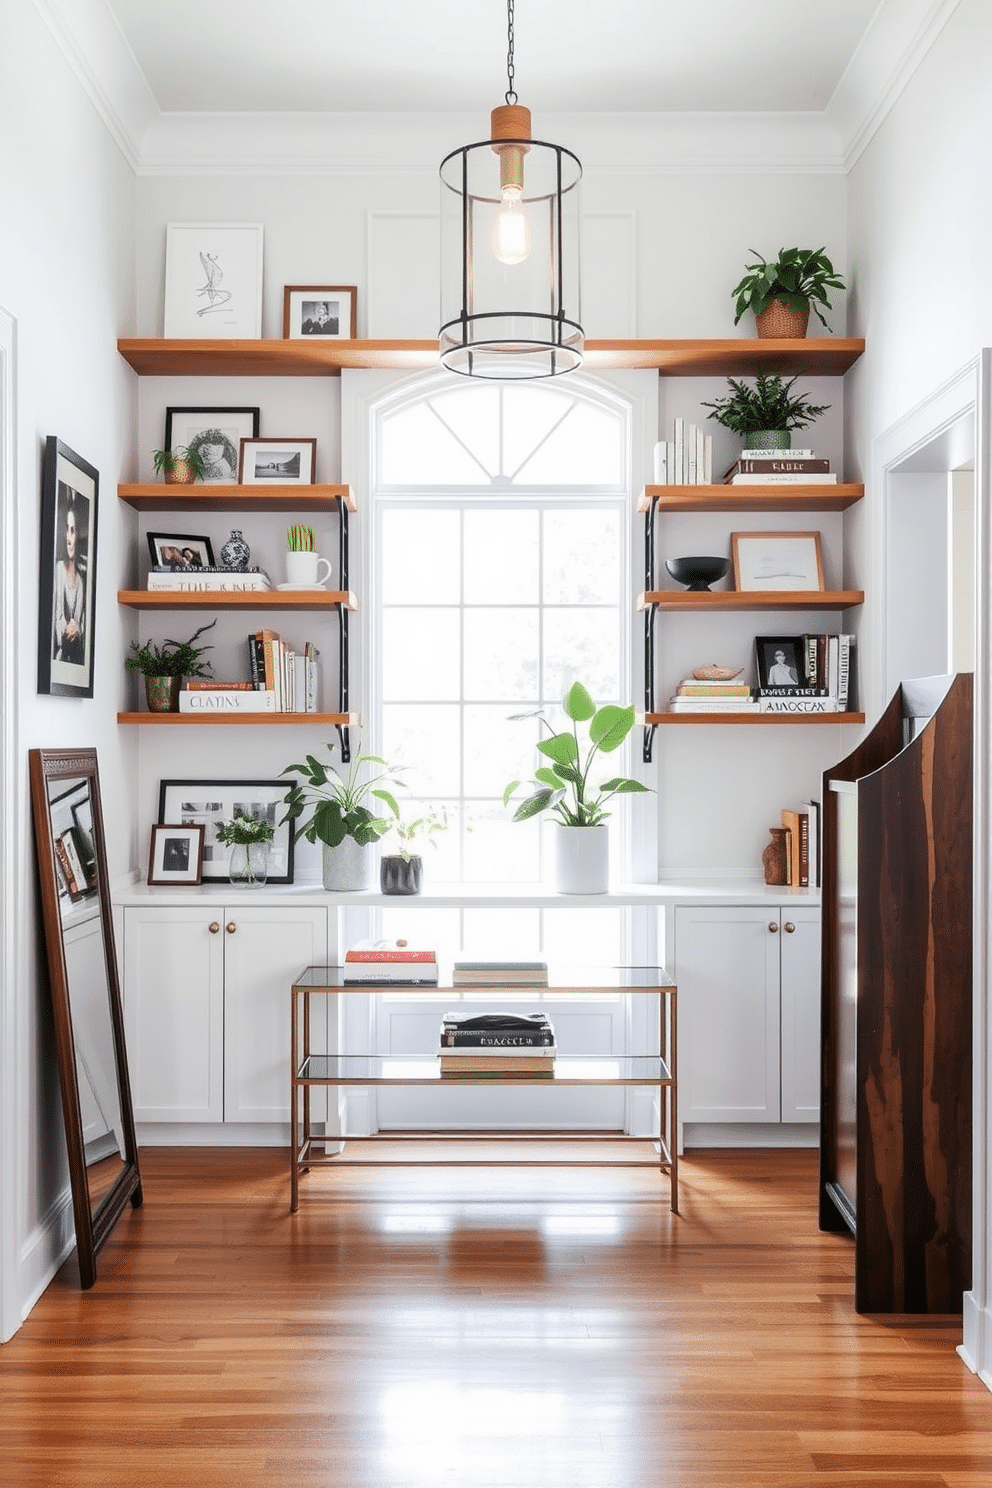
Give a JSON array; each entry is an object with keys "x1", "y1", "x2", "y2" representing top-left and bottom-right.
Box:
[{"x1": 503, "y1": 682, "x2": 650, "y2": 827}]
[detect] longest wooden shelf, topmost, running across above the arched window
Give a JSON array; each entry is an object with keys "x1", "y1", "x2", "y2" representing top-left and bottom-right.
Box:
[{"x1": 117, "y1": 336, "x2": 864, "y2": 376}]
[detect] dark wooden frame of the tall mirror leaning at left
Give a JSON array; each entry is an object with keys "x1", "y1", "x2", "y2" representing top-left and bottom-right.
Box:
[{"x1": 28, "y1": 748, "x2": 141, "y2": 1289}]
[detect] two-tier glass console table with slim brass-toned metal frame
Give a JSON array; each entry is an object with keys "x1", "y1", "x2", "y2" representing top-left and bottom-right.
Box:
[{"x1": 290, "y1": 966, "x2": 678, "y2": 1214}]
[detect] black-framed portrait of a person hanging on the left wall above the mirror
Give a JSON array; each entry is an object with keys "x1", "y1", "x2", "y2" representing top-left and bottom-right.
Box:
[{"x1": 37, "y1": 434, "x2": 100, "y2": 698}]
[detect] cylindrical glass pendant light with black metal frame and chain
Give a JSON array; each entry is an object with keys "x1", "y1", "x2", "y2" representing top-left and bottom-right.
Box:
[{"x1": 439, "y1": 0, "x2": 583, "y2": 379}]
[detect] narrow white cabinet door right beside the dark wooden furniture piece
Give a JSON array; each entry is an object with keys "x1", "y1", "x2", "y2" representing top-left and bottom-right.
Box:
[{"x1": 779, "y1": 905, "x2": 819, "y2": 1122}]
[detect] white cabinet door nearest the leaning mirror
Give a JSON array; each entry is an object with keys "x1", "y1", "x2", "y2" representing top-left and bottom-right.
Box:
[{"x1": 123, "y1": 906, "x2": 224, "y2": 1122}]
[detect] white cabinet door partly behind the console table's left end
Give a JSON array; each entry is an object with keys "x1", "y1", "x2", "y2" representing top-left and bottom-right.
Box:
[{"x1": 223, "y1": 903, "x2": 327, "y2": 1122}]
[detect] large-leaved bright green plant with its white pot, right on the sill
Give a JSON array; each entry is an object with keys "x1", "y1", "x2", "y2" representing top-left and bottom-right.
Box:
[{"x1": 503, "y1": 682, "x2": 648, "y2": 894}]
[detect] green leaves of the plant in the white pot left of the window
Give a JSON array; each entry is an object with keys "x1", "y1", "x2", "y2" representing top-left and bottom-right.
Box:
[{"x1": 283, "y1": 743, "x2": 402, "y2": 847}]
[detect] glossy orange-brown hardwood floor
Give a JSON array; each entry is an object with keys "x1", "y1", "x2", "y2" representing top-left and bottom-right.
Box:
[{"x1": 0, "y1": 1147, "x2": 992, "y2": 1488}]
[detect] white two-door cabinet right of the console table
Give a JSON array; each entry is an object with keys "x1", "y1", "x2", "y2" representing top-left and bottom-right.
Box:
[{"x1": 674, "y1": 905, "x2": 819, "y2": 1122}]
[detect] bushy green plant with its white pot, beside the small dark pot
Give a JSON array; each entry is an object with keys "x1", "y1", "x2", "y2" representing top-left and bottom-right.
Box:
[{"x1": 283, "y1": 744, "x2": 400, "y2": 891}]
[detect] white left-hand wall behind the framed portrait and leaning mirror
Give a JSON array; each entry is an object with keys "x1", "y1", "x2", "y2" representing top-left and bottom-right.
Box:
[{"x1": 0, "y1": 0, "x2": 135, "y2": 1330}]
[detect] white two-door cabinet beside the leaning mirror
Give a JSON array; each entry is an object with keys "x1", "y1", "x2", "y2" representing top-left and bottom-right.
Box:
[{"x1": 123, "y1": 900, "x2": 327, "y2": 1122}]
